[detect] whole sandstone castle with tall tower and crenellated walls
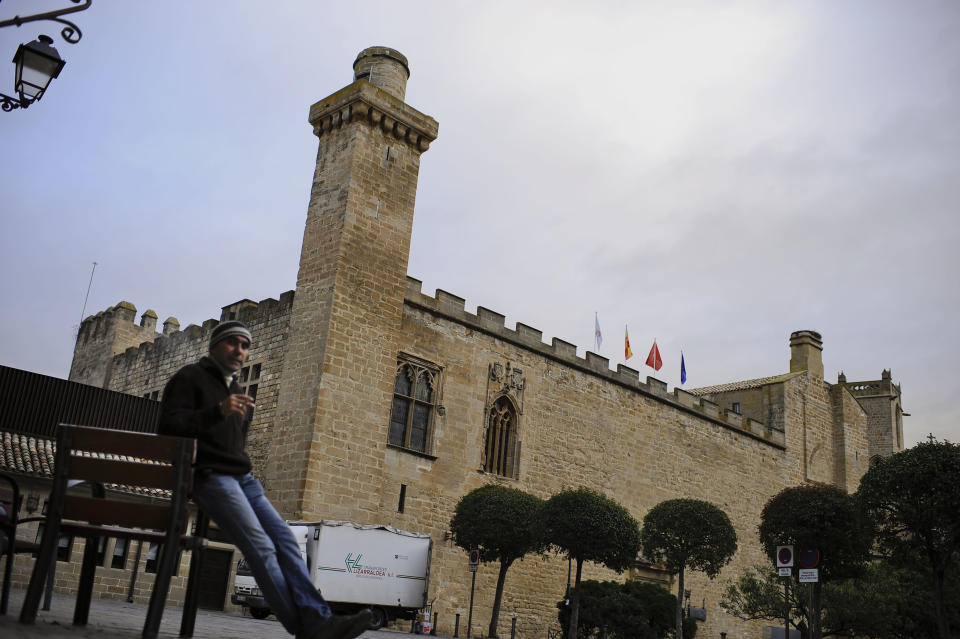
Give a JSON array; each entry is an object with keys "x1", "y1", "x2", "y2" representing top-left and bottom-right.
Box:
[{"x1": 70, "y1": 47, "x2": 903, "y2": 637}]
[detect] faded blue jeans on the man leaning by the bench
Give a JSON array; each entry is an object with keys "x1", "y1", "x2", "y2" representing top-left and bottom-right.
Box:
[{"x1": 193, "y1": 473, "x2": 331, "y2": 635}]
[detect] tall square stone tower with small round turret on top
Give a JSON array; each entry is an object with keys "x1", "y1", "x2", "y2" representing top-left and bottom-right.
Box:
[{"x1": 265, "y1": 47, "x2": 437, "y2": 518}]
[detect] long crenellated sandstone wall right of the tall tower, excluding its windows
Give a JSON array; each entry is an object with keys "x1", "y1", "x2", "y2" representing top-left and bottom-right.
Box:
[{"x1": 338, "y1": 288, "x2": 866, "y2": 636}]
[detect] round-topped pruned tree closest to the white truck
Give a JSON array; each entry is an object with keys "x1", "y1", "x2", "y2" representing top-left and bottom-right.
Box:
[{"x1": 450, "y1": 484, "x2": 546, "y2": 637}]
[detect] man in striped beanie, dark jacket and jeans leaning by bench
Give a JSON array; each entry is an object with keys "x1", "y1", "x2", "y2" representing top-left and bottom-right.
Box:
[{"x1": 160, "y1": 321, "x2": 372, "y2": 639}]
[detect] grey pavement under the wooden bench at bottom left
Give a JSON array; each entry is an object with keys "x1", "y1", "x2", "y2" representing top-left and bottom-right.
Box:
[{"x1": 0, "y1": 589, "x2": 396, "y2": 639}]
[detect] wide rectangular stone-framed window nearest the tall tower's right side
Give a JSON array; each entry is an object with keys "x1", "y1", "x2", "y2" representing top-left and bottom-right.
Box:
[{"x1": 388, "y1": 357, "x2": 440, "y2": 453}]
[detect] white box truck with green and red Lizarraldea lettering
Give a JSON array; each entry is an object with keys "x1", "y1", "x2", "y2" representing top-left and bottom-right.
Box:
[{"x1": 230, "y1": 520, "x2": 433, "y2": 629}]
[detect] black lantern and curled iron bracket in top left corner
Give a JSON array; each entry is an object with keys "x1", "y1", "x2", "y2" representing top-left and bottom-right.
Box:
[{"x1": 0, "y1": 0, "x2": 92, "y2": 111}]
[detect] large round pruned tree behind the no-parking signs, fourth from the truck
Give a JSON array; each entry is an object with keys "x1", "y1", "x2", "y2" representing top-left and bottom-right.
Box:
[{"x1": 758, "y1": 484, "x2": 873, "y2": 639}]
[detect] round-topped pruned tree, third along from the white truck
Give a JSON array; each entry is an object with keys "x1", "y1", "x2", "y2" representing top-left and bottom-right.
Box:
[{"x1": 640, "y1": 499, "x2": 737, "y2": 637}]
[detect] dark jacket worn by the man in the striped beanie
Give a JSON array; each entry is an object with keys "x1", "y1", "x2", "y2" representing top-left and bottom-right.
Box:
[{"x1": 160, "y1": 357, "x2": 250, "y2": 475}]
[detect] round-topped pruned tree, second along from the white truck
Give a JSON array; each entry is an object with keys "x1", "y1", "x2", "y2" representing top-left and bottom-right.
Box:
[{"x1": 543, "y1": 487, "x2": 640, "y2": 639}]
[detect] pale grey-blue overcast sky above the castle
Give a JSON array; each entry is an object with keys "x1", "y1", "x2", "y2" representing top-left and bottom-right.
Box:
[{"x1": 0, "y1": 0, "x2": 960, "y2": 444}]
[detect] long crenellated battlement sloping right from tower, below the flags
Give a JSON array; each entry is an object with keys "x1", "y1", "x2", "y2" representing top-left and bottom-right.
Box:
[{"x1": 404, "y1": 276, "x2": 786, "y2": 448}]
